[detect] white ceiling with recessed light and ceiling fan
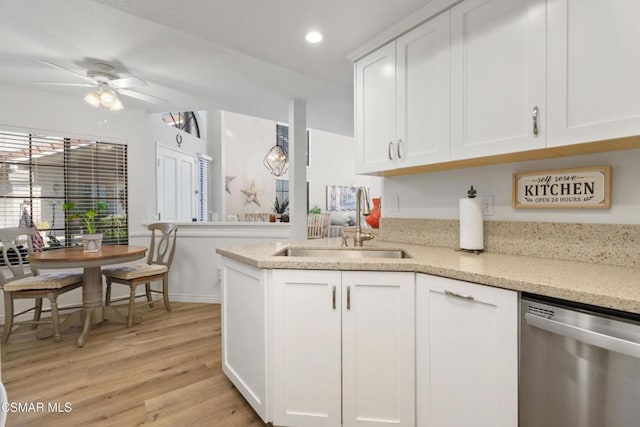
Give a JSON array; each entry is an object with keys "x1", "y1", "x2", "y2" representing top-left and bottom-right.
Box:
[{"x1": 0, "y1": 0, "x2": 431, "y2": 135}]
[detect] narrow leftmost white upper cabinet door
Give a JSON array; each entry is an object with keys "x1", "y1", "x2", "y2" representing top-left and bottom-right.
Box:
[{"x1": 355, "y1": 42, "x2": 396, "y2": 173}]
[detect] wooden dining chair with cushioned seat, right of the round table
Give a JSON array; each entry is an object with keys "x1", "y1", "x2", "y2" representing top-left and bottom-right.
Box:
[{"x1": 102, "y1": 223, "x2": 178, "y2": 328}]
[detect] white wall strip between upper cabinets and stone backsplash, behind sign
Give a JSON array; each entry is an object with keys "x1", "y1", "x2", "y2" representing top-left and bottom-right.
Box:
[{"x1": 382, "y1": 149, "x2": 640, "y2": 224}]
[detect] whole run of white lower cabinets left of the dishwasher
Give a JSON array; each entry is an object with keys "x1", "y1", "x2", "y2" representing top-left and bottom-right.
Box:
[{"x1": 222, "y1": 258, "x2": 518, "y2": 427}]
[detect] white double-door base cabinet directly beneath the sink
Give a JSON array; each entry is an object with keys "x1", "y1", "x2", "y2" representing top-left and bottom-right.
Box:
[{"x1": 272, "y1": 270, "x2": 415, "y2": 427}]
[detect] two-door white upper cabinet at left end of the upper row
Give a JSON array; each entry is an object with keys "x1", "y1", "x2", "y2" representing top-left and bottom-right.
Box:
[{"x1": 356, "y1": 11, "x2": 451, "y2": 173}]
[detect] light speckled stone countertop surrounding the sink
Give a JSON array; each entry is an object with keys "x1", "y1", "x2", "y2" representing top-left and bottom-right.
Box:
[{"x1": 216, "y1": 238, "x2": 640, "y2": 314}]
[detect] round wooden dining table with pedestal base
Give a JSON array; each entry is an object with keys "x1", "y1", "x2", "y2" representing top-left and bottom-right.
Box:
[{"x1": 29, "y1": 245, "x2": 147, "y2": 347}]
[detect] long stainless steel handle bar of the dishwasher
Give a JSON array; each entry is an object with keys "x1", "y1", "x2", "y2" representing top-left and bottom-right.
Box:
[{"x1": 524, "y1": 313, "x2": 640, "y2": 359}]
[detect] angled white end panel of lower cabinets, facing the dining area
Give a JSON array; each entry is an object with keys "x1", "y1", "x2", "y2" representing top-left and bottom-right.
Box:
[{"x1": 222, "y1": 258, "x2": 270, "y2": 422}]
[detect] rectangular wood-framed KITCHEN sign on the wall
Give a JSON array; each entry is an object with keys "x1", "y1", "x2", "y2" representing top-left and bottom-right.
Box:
[{"x1": 512, "y1": 166, "x2": 611, "y2": 209}]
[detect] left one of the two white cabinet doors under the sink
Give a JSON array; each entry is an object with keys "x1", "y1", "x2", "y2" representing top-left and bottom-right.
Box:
[{"x1": 272, "y1": 270, "x2": 341, "y2": 427}]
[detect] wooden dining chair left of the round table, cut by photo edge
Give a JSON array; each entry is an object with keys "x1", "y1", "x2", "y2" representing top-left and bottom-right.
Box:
[{"x1": 0, "y1": 227, "x2": 83, "y2": 343}]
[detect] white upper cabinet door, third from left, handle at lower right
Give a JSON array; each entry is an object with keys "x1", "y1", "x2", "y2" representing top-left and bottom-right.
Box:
[{"x1": 451, "y1": 0, "x2": 546, "y2": 159}]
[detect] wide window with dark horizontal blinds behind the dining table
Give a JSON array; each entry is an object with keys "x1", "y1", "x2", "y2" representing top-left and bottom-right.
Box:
[{"x1": 0, "y1": 131, "x2": 128, "y2": 248}]
